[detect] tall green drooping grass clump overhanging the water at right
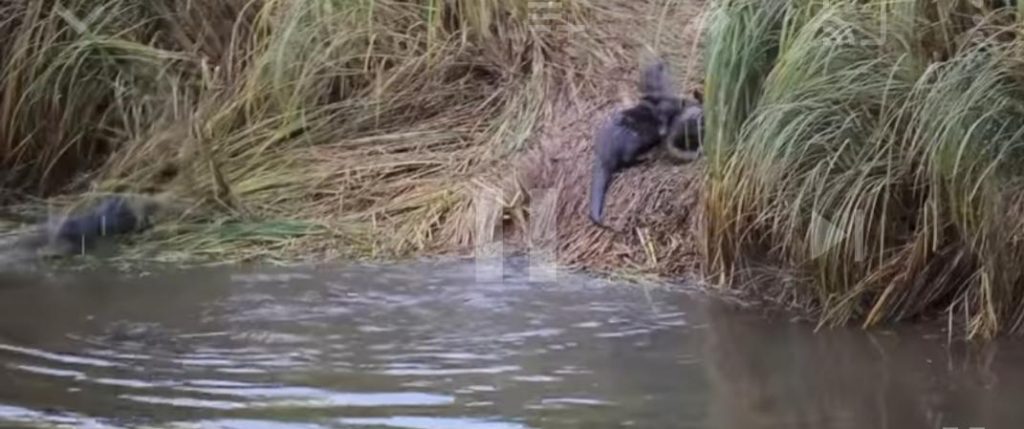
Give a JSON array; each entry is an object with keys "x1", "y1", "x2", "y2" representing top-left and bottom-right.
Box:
[{"x1": 702, "y1": 0, "x2": 1024, "y2": 337}]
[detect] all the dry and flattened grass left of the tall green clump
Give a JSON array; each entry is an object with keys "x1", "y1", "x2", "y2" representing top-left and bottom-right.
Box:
[{"x1": 0, "y1": 0, "x2": 703, "y2": 273}]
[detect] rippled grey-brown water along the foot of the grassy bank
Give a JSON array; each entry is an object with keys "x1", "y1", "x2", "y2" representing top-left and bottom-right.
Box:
[{"x1": 0, "y1": 256, "x2": 1024, "y2": 429}]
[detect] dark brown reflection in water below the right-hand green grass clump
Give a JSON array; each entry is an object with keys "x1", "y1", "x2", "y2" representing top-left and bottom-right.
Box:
[{"x1": 706, "y1": 308, "x2": 1024, "y2": 429}]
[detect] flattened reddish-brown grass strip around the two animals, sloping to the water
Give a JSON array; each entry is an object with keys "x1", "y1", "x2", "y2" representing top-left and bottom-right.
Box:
[{"x1": 456, "y1": 0, "x2": 706, "y2": 280}]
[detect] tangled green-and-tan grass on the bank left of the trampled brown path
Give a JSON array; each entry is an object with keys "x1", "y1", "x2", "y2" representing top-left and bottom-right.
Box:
[{"x1": 0, "y1": 0, "x2": 600, "y2": 259}]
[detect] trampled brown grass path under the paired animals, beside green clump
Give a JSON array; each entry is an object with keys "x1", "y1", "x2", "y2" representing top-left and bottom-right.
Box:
[{"x1": 475, "y1": 1, "x2": 707, "y2": 277}]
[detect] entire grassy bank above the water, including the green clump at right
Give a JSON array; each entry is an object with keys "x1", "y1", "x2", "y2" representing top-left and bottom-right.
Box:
[{"x1": 0, "y1": 0, "x2": 1024, "y2": 338}]
